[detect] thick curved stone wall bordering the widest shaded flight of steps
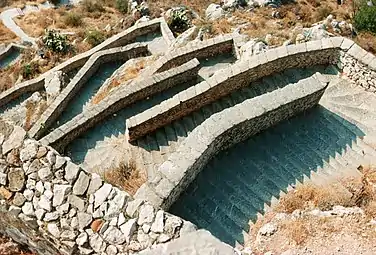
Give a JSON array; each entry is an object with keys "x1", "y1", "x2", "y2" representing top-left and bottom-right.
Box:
[{"x1": 135, "y1": 73, "x2": 328, "y2": 209}]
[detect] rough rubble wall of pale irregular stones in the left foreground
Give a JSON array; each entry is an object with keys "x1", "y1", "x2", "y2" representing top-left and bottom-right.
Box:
[{"x1": 0, "y1": 120, "x2": 196, "y2": 255}]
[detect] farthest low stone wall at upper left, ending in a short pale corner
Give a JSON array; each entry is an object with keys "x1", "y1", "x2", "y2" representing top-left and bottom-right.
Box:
[{"x1": 0, "y1": 18, "x2": 174, "y2": 106}]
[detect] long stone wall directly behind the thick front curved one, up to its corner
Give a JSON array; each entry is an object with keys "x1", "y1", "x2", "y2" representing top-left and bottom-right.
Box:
[{"x1": 127, "y1": 40, "x2": 339, "y2": 141}]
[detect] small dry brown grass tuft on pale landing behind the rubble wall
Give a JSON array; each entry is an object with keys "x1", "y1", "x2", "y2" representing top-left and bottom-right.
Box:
[{"x1": 104, "y1": 160, "x2": 146, "y2": 195}]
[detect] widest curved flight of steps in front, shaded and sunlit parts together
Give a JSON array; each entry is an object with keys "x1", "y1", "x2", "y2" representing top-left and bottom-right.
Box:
[{"x1": 170, "y1": 67, "x2": 376, "y2": 245}]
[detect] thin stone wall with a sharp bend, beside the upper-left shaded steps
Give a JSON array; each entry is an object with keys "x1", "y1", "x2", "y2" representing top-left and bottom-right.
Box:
[{"x1": 29, "y1": 43, "x2": 149, "y2": 139}]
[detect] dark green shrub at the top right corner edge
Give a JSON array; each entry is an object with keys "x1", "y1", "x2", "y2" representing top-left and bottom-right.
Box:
[{"x1": 354, "y1": 5, "x2": 376, "y2": 33}]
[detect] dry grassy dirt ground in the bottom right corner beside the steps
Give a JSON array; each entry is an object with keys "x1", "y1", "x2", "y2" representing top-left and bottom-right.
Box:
[{"x1": 246, "y1": 166, "x2": 376, "y2": 255}]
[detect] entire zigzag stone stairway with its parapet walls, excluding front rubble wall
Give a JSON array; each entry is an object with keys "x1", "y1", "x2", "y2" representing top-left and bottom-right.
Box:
[{"x1": 0, "y1": 16, "x2": 376, "y2": 254}]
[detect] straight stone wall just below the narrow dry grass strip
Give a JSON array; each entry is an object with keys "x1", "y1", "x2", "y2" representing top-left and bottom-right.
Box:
[{"x1": 41, "y1": 59, "x2": 200, "y2": 149}]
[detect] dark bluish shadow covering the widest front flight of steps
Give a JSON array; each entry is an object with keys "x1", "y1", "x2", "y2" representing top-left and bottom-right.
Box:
[{"x1": 170, "y1": 106, "x2": 364, "y2": 245}]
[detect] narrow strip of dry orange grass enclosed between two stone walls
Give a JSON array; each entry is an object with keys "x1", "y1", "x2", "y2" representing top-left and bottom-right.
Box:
[{"x1": 91, "y1": 59, "x2": 147, "y2": 104}]
